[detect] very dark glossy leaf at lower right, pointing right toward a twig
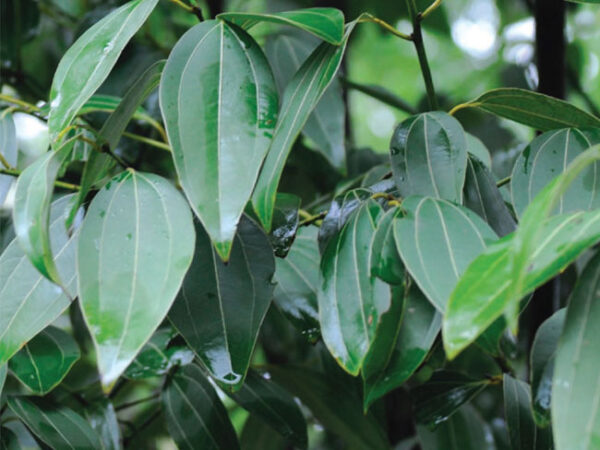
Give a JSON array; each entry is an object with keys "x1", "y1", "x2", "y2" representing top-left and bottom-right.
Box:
[{"x1": 411, "y1": 370, "x2": 490, "y2": 429}]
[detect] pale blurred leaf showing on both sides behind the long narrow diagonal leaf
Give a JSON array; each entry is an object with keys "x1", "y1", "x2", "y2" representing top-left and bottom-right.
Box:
[{"x1": 265, "y1": 29, "x2": 346, "y2": 173}]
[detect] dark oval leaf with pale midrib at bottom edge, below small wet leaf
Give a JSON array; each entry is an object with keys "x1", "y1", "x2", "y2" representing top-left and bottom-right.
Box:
[{"x1": 161, "y1": 364, "x2": 239, "y2": 450}]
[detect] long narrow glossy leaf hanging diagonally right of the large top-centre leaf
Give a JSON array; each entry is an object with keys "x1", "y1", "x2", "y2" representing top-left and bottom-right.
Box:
[{"x1": 252, "y1": 22, "x2": 355, "y2": 230}]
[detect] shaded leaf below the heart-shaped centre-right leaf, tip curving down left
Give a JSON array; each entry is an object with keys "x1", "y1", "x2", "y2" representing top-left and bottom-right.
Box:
[{"x1": 364, "y1": 285, "x2": 442, "y2": 407}]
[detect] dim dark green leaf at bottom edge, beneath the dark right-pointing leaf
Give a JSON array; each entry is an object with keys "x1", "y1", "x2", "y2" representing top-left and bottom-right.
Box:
[{"x1": 417, "y1": 405, "x2": 496, "y2": 450}]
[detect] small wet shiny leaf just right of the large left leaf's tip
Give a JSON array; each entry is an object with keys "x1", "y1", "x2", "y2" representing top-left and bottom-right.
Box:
[{"x1": 125, "y1": 328, "x2": 194, "y2": 380}]
